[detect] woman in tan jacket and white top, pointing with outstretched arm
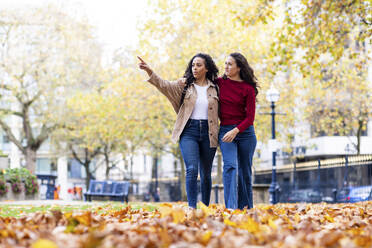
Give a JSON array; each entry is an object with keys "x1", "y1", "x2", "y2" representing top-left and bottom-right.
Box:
[{"x1": 138, "y1": 53, "x2": 219, "y2": 208}]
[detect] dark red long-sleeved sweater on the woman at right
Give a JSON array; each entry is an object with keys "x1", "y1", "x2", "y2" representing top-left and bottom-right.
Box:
[{"x1": 217, "y1": 78, "x2": 256, "y2": 132}]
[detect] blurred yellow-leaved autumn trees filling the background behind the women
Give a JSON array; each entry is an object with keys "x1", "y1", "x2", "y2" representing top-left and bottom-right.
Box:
[{"x1": 0, "y1": 0, "x2": 372, "y2": 190}]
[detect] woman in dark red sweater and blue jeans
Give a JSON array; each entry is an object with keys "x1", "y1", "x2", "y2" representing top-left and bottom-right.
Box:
[{"x1": 217, "y1": 53, "x2": 258, "y2": 209}]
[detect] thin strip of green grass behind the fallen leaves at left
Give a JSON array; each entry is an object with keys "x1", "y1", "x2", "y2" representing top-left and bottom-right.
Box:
[{"x1": 0, "y1": 202, "x2": 157, "y2": 218}]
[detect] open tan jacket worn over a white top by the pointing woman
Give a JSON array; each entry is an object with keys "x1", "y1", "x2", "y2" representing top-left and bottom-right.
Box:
[{"x1": 148, "y1": 73, "x2": 219, "y2": 147}]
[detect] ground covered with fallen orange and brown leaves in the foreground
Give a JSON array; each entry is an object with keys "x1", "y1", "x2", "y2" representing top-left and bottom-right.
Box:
[{"x1": 0, "y1": 202, "x2": 372, "y2": 248}]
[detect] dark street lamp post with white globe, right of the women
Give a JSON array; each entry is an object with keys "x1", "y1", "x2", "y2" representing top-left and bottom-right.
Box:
[{"x1": 266, "y1": 85, "x2": 280, "y2": 204}]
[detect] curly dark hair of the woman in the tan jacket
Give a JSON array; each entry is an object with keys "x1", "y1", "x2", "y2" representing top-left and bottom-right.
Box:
[{"x1": 180, "y1": 53, "x2": 219, "y2": 106}]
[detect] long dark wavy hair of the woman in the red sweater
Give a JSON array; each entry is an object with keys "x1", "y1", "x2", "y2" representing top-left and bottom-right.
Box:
[{"x1": 223, "y1": 53, "x2": 259, "y2": 96}]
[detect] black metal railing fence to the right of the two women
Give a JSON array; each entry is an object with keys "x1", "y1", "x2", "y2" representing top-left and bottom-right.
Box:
[{"x1": 254, "y1": 155, "x2": 372, "y2": 202}]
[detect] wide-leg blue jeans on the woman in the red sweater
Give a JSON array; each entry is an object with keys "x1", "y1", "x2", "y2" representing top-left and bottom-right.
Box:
[{"x1": 218, "y1": 125, "x2": 257, "y2": 209}]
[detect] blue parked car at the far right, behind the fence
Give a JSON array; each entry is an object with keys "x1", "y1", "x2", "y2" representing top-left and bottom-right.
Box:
[{"x1": 336, "y1": 185, "x2": 372, "y2": 202}]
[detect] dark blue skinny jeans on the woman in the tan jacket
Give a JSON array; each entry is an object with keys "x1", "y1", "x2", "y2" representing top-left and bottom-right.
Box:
[{"x1": 180, "y1": 119, "x2": 216, "y2": 208}]
